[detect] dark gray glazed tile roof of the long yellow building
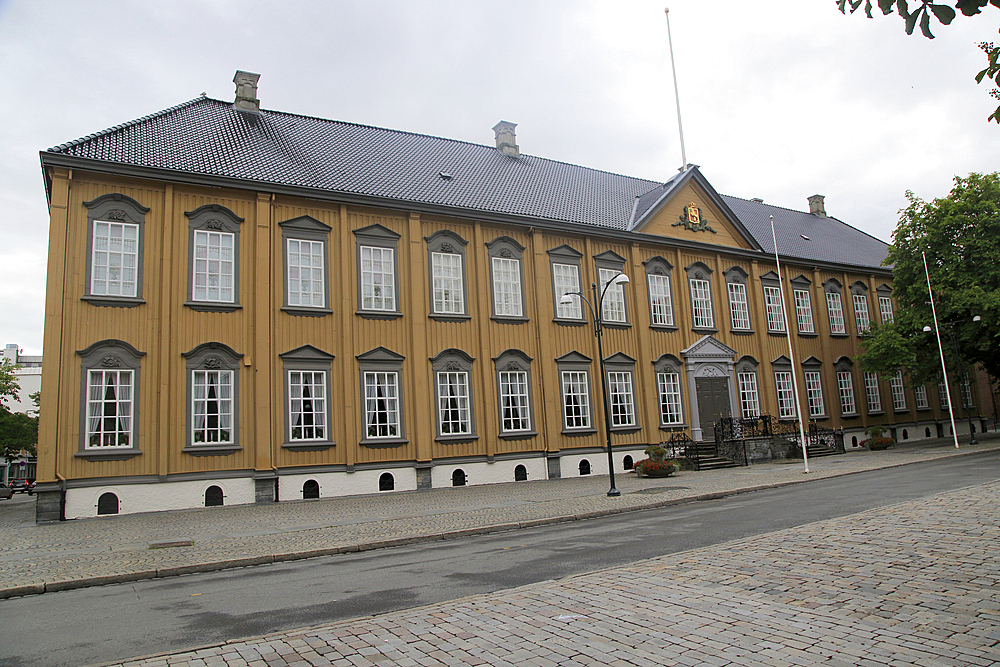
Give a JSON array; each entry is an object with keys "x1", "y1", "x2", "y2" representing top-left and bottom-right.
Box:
[{"x1": 43, "y1": 97, "x2": 886, "y2": 266}]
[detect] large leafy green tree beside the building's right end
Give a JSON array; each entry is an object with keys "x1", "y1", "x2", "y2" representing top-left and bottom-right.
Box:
[{"x1": 858, "y1": 173, "x2": 1000, "y2": 384}]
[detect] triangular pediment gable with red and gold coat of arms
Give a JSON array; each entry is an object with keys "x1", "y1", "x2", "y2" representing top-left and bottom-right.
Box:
[{"x1": 631, "y1": 166, "x2": 761, "y2": 250}]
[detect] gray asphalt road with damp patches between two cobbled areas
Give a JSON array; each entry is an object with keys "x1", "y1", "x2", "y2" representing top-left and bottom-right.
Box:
[{"x1": 0, "y1": 452, "x2": 1000, "y2": 667}]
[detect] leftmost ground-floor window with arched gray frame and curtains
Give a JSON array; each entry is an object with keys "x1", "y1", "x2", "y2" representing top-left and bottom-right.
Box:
[{"x1": 76, "y1": 340, "x2": 145, "y2": 460}]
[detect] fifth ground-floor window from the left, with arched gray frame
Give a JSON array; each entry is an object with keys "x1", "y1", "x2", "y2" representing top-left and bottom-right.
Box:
[{"x1": 431, "y1": 349, "x2": 476, "y2": 443}]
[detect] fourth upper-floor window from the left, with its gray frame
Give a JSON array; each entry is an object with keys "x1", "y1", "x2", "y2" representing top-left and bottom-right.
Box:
[{"x1": 354, "y1": 224, "x2": 403, "y2": 319}]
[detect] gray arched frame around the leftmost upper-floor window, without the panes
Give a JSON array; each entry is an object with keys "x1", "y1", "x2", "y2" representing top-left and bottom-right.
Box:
[{"x1": 80, "y1": 192, "x2": 149, "y2": 308}]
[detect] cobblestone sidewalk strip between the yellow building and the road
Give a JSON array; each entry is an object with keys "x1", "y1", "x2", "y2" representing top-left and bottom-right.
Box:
[{"x1": 0, "y1": 433, "x2": 1000, "y2": 598}]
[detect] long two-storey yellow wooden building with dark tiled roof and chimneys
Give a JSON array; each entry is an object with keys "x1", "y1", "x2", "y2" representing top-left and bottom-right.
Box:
[{"x1": 31, "y1": 72, "x2": 968, "y2": 520}]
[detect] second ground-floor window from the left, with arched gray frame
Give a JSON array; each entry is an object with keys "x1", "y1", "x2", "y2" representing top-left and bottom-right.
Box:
[{"x1": 182, "y1": 343, "x2": 243, "y2": 456}]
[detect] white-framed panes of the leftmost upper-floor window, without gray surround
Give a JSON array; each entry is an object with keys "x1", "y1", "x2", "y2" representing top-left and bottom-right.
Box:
[{"x1": 90, "y1": 220, "x2": 139, "y2": 297}]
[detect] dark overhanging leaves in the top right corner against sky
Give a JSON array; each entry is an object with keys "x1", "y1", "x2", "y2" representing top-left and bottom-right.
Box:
[{"x1": 835, "y1": 0, "x2": 1000, "y2": 123}]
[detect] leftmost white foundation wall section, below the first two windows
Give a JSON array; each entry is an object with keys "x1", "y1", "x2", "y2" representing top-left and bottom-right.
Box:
[{"x1": 66, "y1": 478, "x2": 254, "y2": 519}]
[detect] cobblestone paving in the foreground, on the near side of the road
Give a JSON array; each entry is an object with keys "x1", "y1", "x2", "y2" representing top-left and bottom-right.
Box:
[{"x1": 97, "y1": 456, "x2": 1000, "y2": 667}]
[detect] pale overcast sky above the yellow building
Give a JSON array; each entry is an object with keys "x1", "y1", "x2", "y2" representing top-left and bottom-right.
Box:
[{"x1": 0, "y1": 0, "x2": 1000, "y2": 354}]
